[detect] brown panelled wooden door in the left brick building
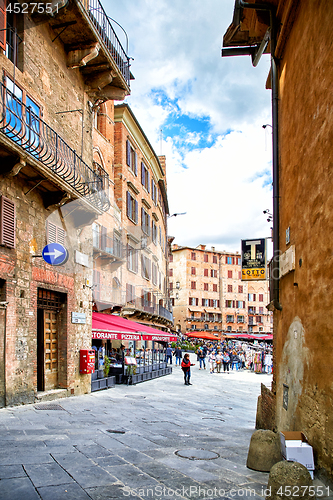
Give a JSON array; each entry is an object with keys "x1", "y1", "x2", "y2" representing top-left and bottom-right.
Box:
[{"x1": 44, "y1": 309, "x2": 58, "y2": 391}]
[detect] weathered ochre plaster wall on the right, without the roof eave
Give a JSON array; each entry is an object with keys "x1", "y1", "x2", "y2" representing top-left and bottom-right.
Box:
[{"x1": 274, "y1": 0, "x2": 333, "y2": 474}]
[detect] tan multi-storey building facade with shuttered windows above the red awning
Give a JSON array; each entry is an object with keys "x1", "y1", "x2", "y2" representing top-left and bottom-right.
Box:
[{"x1": 88, "y1": 101, "x2": 173, "y2": 340}]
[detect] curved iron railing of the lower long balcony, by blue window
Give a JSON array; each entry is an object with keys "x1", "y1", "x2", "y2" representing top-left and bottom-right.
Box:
[{"x1": 0, "y1": 83, "x2": 110, "y2": 211}]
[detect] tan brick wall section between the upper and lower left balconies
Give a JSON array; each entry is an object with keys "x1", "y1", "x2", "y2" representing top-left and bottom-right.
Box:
[{"x1": 0, "y1": 15, "x2": 92, "y2": 166}]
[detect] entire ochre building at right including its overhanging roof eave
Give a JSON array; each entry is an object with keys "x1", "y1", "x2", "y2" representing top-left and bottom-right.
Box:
[{"x1": 224, "y1": 0, "x2": 333, "y2": 477}]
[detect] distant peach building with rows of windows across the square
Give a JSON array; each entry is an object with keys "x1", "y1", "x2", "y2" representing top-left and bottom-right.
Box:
[{"x1": 169, "y1": 244, "x2": 273, "y2": 338}]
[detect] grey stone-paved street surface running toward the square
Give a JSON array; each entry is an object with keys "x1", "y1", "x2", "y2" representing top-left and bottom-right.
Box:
[{"x1": 0, "y1": 356, "x2": 326, "y2": 500}]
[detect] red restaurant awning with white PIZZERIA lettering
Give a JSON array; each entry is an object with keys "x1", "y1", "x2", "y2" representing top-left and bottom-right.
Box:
[{"x1": 92, "y1": 312, "x2": 178, "y2": 342}]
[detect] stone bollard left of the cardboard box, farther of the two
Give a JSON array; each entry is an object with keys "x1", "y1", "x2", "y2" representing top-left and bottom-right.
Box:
[{"x1": 246, "y1": 429, "x2": 282, "y2": 472}]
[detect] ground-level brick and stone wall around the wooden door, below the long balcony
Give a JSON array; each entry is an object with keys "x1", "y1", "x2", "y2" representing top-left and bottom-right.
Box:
[{"x1": 0, "y1": 170, "x2": 91, "y2": 404}]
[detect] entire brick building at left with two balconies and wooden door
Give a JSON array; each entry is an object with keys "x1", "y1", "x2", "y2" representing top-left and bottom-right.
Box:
[{"x1": 0, "y1": 0, "x2": 130, "y2": 406}]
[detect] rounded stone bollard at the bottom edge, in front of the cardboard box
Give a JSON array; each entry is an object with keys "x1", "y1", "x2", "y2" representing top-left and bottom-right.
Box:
[{"x1": 265, "y1": 460, "x2": 315, "y2": 500}]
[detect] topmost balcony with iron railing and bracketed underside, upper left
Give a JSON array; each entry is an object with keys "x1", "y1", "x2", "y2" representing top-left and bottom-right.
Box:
[{"x1": 28, "y1": 0, "x2": 131, "y2": 100}]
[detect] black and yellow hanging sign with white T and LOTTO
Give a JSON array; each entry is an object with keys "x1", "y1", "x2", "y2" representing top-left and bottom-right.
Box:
[{"x1": 242, "y1": 238, "x2": 267, "y2": 281}]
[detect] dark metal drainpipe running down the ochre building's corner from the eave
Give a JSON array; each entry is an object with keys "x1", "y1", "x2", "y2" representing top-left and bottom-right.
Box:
[{"x1": 238, "y1": 0, "x2": 282, "y2": 311}]
